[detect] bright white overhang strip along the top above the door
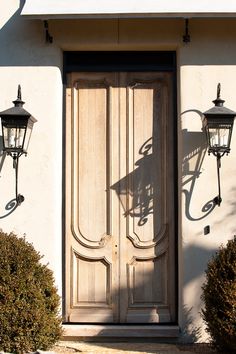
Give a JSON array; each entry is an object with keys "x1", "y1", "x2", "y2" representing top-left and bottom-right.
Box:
[{"x1": 21, "y1": 0, "x2": 236, "y2": 19}]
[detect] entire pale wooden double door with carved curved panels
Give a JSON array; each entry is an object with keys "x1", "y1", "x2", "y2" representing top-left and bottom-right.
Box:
[{"x1": 65, "y1": 72, "x2": 176, "y2": 323}]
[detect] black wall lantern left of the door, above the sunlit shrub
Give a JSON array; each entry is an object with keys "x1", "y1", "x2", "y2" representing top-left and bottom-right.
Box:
[{"x1": 0, "y1": 85, "x2": 37, "y2": 205}]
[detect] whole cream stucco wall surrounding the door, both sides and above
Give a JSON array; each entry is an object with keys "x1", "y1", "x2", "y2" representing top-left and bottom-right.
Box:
[{"x1": 0, "y1": 0, "x2": 236, "y2": 340}]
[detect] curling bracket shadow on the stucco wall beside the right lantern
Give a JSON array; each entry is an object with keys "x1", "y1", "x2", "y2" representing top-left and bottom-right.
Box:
[{"x1": 182, "y1": 110, "x2": 216, "y2": 221}]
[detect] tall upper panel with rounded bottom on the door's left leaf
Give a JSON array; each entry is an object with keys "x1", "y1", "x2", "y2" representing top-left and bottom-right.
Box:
[{"x1": 74, "y1": 81, "x2": 110, "y2": 244}]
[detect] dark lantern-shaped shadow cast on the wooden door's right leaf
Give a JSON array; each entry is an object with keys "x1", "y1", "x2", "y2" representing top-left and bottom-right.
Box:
[{"x1": 110, "y1": 137, "x2": 157, "y2": 226}]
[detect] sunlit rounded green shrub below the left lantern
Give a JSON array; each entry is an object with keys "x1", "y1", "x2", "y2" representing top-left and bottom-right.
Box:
[{"x1": 0, "y1": 231, "x2": 62, "y2": 353}]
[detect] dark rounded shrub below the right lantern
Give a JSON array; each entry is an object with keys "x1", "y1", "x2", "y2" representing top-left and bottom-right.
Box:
[{"x1": 202, "y1": 237, "x2": 236, "y2": 353}]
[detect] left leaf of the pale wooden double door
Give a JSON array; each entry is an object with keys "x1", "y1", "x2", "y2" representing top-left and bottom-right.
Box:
[{"x1": 66, "y1": 73, "x2": 119, "y2": 323}]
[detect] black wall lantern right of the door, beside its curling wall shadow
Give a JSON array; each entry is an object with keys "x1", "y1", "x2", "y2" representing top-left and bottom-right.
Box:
[{"x1": 203, "y1": 84, "x2": 236, "y2": 206}]
